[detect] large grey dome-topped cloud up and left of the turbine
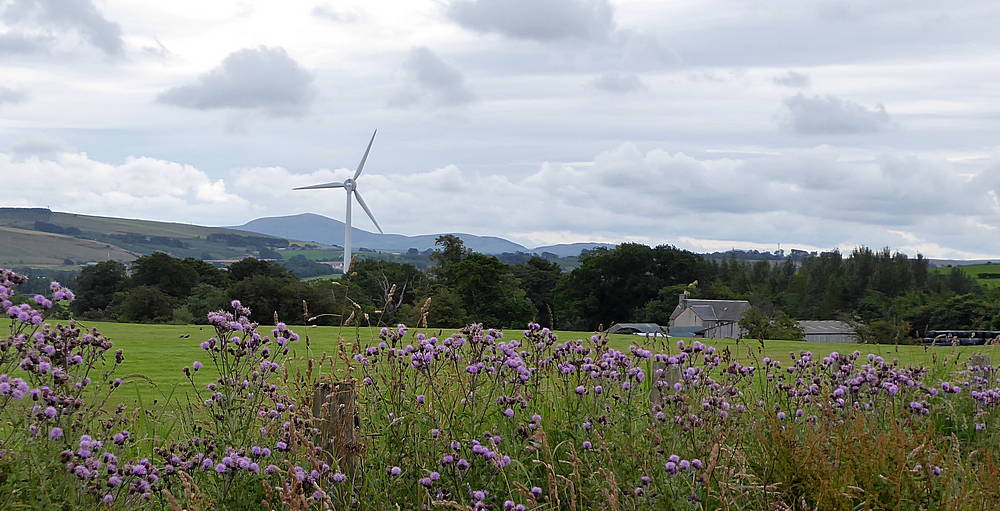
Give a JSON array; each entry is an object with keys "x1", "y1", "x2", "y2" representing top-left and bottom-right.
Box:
[{"x1": 157, "y1": 46, "x2": 314, "y2": 117}]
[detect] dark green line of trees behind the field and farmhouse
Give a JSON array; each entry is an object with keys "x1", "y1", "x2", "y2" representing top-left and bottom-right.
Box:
[{"x1": 62, "y1": 235, "x2": 1000, "y2": 341}]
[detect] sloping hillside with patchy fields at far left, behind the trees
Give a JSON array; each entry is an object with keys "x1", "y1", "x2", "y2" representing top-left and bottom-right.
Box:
[{"x1": 0, "y1": 208, "x2": 289, "y2": 267}]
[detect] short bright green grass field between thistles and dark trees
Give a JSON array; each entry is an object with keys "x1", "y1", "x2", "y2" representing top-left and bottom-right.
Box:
[{"x1": 82, "y1": 322, "x2": 1000, "y2": 404}]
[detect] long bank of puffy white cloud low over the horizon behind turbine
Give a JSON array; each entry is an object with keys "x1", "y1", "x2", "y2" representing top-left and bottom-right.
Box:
[{"x1": 7, "y1": 144, "x2": 1000, "y2": 257}]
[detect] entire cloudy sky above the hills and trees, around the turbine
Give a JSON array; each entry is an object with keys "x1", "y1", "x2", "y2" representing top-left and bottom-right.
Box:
[{"x1": 0, "y1": 0, "x2": 1000, "y2": 259}]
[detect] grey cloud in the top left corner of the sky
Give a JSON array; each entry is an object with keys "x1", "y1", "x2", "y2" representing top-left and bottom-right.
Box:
[{"x1": 0, "y1": 0, "x2": 125, "y2": 56}]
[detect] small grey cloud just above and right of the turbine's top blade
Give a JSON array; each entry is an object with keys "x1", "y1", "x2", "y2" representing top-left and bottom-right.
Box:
[{"x1": 389, "y1": 46, "x2": 476, "y2": 107}]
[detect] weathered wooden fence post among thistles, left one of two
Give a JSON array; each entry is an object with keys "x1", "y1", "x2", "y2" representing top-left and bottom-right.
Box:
[{"x1": 312, "y1": 382, "x2": 361, "y2": 478}]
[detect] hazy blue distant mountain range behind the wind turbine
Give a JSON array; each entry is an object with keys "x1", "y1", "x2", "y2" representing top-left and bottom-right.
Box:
[{"x1": 229, "y1": 213, "x2": 531, "y2": 254}]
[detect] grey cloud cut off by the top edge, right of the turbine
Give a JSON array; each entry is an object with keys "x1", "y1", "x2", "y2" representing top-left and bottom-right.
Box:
[{"x1": 446, "y1": 0, "x2": 614, "y2": 41}]
